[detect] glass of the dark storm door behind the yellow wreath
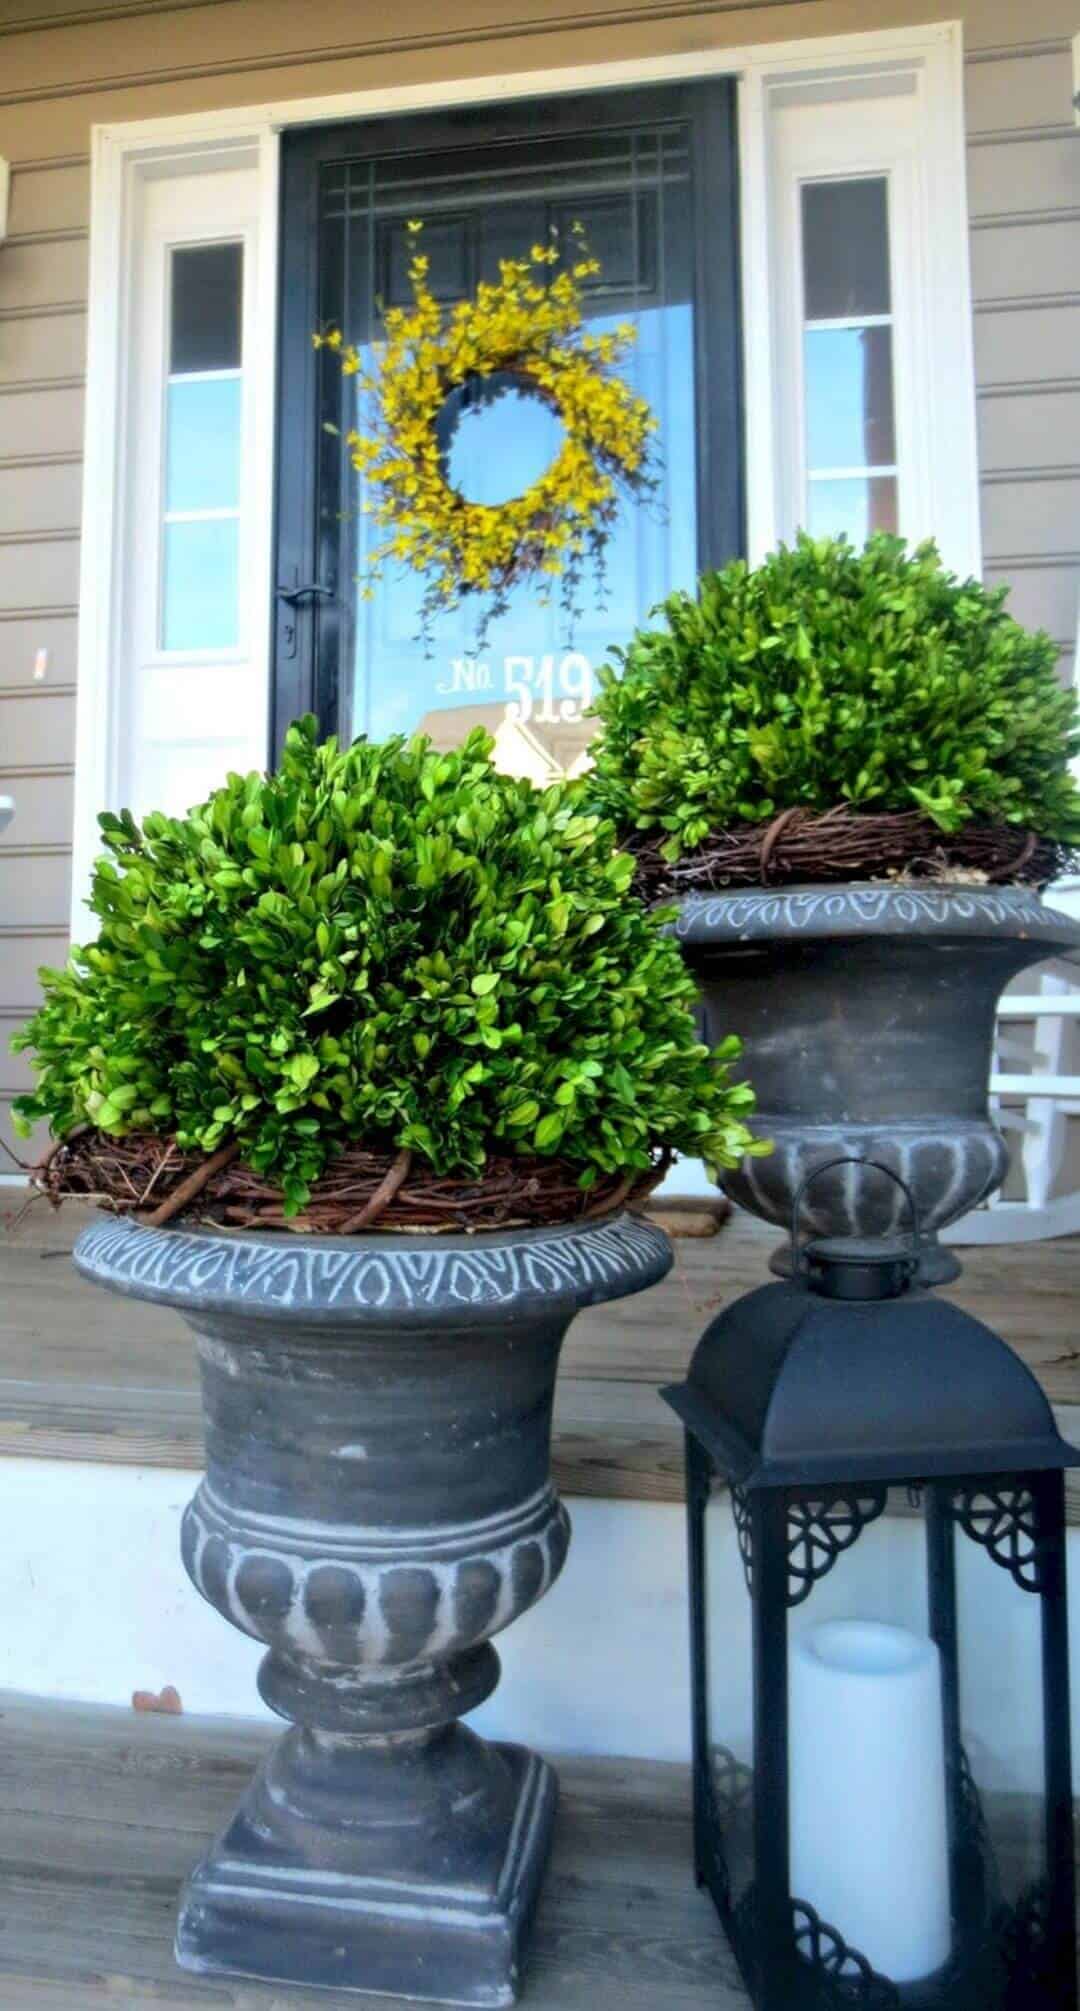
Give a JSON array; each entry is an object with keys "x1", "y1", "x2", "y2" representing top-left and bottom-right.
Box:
[{"x1": 320, "y1": 121, "x2": 698, "y2": 782}]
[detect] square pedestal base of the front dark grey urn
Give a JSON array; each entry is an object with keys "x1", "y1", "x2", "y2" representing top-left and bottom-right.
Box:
[{"x1": 175, "y1": 1725, "x2": 557, "y2": 2005}]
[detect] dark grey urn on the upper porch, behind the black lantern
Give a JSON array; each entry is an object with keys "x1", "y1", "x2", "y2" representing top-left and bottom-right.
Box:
[{"x1": 676, "y1": 883, "x2": 1080, "y2": 1283}]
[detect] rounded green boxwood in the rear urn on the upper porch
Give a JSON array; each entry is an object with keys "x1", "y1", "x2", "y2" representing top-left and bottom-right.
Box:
[{"x1": 593, "y1": 533, "x2": 1080, "y2": 859}]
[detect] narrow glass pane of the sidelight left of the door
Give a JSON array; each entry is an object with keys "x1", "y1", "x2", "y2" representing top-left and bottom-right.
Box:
[{"x1": 159, "y1": 243, "x2": 243, "y2": 652}]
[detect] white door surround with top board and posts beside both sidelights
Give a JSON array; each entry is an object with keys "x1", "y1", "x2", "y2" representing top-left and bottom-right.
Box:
[{"x1": 72, "y1": 20, "x2": 979, "y2": 941}]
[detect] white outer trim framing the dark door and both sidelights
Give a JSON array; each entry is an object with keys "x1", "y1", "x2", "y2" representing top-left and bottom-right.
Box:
[{"x1": 72, "y1": 20, "x2": 981, "y2": 929}]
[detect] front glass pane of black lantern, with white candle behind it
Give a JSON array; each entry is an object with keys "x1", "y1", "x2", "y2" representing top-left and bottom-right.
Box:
[{"x1": 788, "y1": 1486, "x2": 951, "y2": 1985}]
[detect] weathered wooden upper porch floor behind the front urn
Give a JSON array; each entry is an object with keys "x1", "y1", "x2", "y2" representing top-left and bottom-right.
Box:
[{"x1": 0, "y1": 1191, "x2": 1080, "y2": 1520}]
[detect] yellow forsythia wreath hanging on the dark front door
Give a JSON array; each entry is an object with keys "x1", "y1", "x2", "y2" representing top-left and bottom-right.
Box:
[{"x1": 312, "y1": 223, "x2": 656, "y2": 631}]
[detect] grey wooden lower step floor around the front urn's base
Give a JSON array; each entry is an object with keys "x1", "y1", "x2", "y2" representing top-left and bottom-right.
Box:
[{"x1": 0, "y1": 1693, "x2": 748, "y2": 2011}]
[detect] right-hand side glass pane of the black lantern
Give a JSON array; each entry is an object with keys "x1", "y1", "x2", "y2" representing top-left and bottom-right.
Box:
[{"x1": 955, "y1": 1484, "x2": 1048, "y2": 1929}]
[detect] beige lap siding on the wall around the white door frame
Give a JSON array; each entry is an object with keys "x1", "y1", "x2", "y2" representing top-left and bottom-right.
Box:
[{"x1": 0, "y1": 0, "x2": 1080, "y2": 1166}]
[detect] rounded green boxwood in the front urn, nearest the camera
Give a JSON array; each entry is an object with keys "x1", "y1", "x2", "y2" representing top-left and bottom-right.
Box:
[{"x1": 16, "y1": 720, "x2": 752, "y2": 1213}]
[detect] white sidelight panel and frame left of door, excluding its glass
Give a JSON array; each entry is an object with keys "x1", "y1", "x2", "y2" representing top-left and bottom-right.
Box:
[{"x1": 70, "y1": 133, "x2": 278, "y2": 925}]
